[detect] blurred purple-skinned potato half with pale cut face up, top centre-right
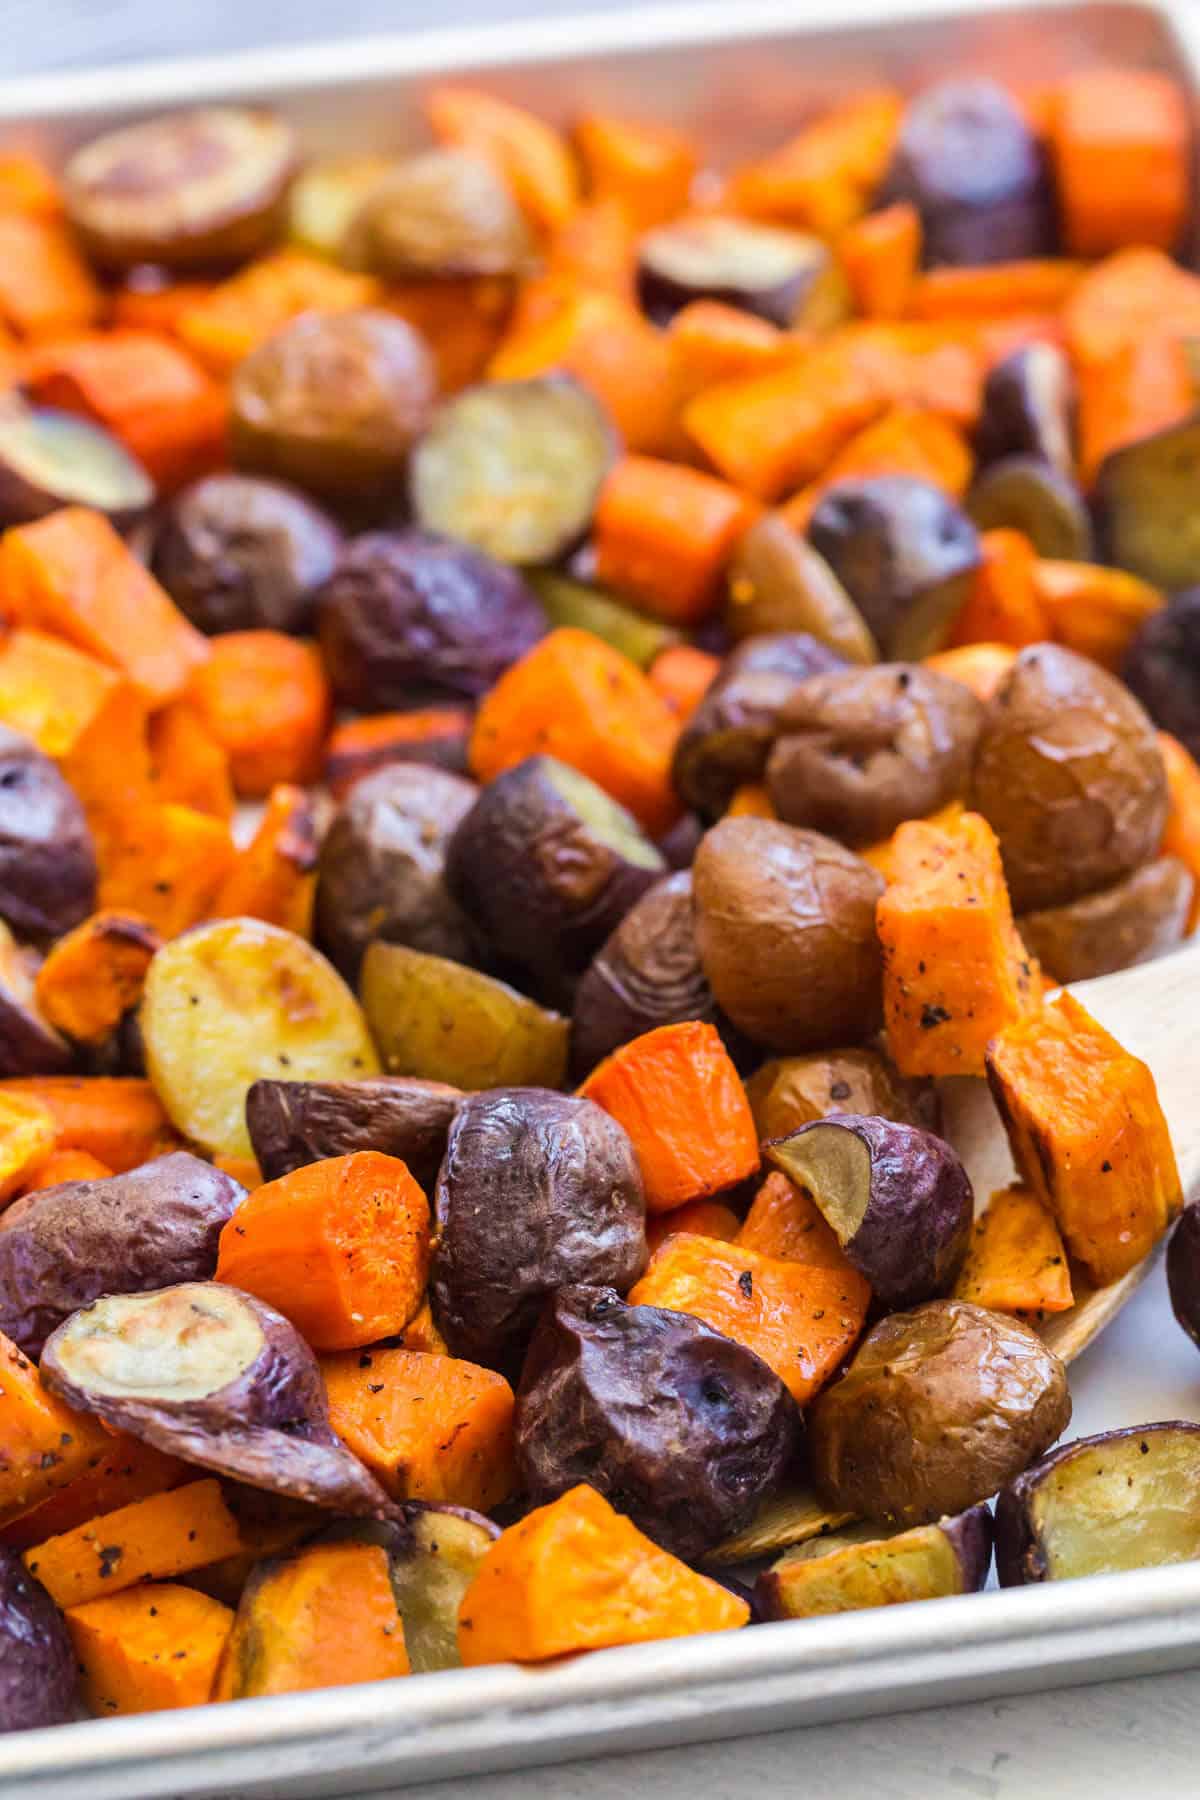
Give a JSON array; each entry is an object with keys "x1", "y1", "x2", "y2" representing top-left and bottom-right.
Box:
[{"x1": 637, "y1": 212, "x2": 847, "y2": 329}]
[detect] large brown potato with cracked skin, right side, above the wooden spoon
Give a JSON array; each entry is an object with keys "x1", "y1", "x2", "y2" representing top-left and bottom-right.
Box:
[{"x1": 970, "y1": 644, "x2": 1168, "y2": 913}]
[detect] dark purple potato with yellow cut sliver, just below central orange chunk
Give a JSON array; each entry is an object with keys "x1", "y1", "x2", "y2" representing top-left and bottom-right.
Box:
[{"x1": 446, "y1": 756, "x2": 666, "y2": 1004}]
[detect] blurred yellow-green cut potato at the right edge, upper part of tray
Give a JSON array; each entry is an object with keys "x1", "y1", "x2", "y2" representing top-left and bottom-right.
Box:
[{"x1": 1096, "y1": 412, "x2": 1200, "y2": 594}]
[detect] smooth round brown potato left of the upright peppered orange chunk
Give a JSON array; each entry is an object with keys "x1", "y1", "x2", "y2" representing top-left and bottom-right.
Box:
[{"x1": 693, "y1": 819, "x2": 883, "y2": 1051}]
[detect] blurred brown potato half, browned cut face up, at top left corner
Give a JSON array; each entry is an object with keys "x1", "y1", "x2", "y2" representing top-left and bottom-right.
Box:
[{"x1": 63, "y1": 106, "x2": 297, "y2": 270}]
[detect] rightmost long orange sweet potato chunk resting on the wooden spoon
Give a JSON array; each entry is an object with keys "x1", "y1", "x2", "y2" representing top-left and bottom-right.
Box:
[{"x1": 988, "y1": 994, "x2": 1182, "y2": 1287}]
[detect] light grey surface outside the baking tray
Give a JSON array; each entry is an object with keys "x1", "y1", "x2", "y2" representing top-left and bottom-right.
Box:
[{"x1": 0, "y1": 0, "x2": 1200, "y2": 1800}]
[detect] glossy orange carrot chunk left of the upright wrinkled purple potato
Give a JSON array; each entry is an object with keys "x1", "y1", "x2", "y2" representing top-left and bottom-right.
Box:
[{"x1": 216, "y1": 1150, "x2": 430, "y2": 1350}]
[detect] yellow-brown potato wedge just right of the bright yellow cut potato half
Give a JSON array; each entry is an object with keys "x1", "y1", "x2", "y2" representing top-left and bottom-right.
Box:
[{"x1": 360, "y1": 941, "x2": 570, "y2": 1093}]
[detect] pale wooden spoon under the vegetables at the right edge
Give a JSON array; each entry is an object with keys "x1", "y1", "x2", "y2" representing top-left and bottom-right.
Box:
[{"x1": 709, "y1": 945, "x2": 1200, "y2": 1562}]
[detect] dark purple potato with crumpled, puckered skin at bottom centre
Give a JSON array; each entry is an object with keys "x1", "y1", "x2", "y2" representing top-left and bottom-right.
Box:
[{"x1": 516, "y1": 1287, "x2": 801, "y2": 1561}]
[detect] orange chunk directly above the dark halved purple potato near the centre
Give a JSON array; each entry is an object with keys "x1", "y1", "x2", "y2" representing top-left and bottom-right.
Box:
[{"x1": 470, "y1": 626, "x2": 680, "y2": 837}]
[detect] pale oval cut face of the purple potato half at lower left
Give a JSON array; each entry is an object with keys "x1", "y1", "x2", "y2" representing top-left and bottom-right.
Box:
[{"x1": 59, "y1": 1282, "x2": 264, "y2": 1402}]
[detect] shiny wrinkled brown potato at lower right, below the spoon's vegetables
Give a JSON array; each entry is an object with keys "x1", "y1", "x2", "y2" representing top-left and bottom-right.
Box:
[{"x1": 808, "y1": 1300, "x2": 1070, "y2": 1525}]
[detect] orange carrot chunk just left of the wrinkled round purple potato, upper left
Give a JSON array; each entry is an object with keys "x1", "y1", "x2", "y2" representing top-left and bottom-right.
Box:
[{"x1": 189, "y1": 632, "x2": 329, "y2": 799}]
